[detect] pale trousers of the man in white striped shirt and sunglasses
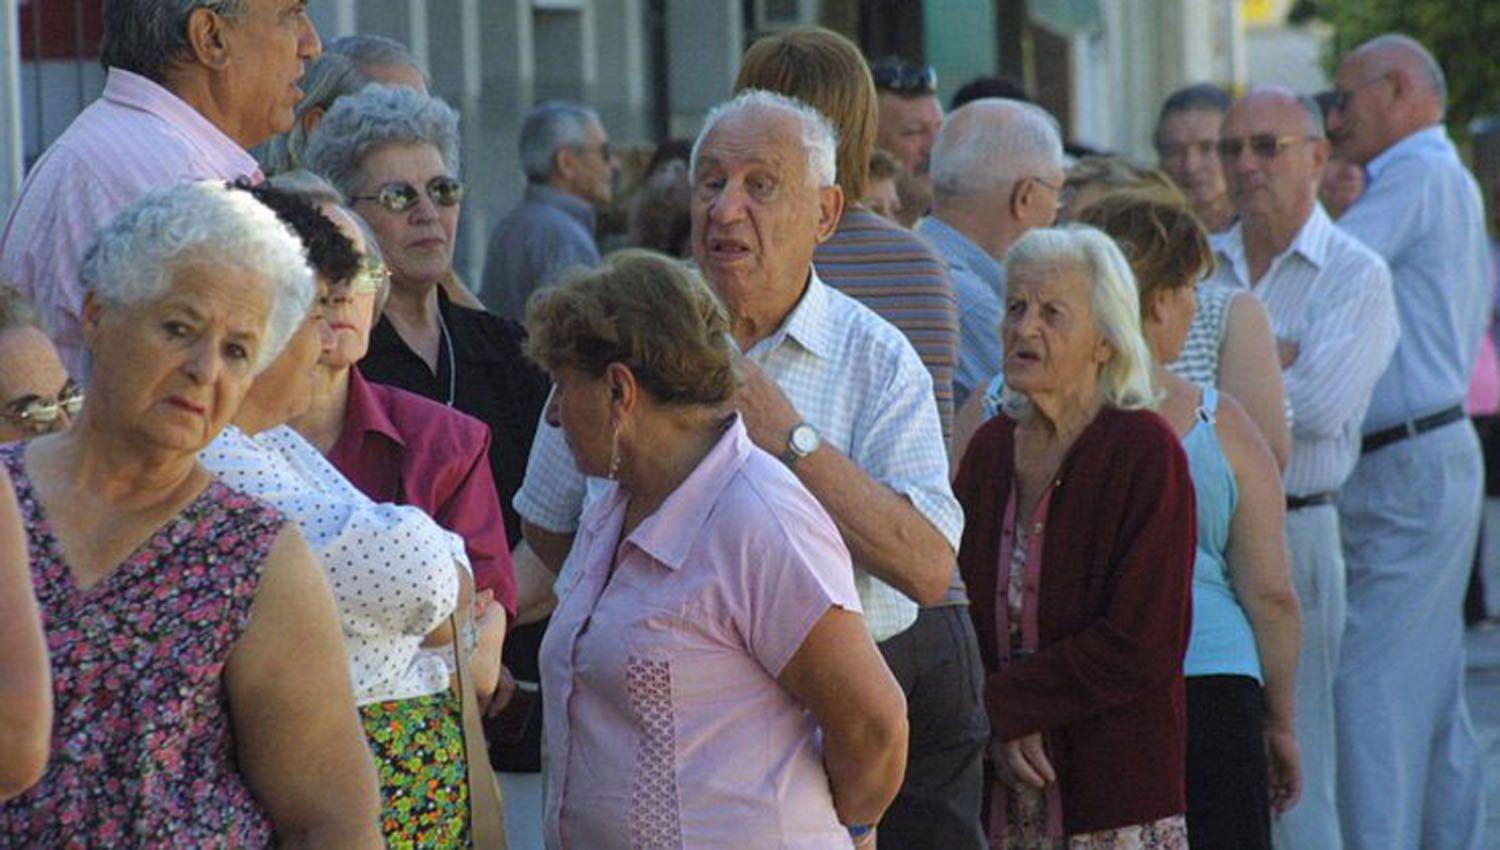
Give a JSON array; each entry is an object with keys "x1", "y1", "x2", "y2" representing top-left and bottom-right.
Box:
[{"x1": 1271, "y1": 505, "x2": 1346, "y2": 850}]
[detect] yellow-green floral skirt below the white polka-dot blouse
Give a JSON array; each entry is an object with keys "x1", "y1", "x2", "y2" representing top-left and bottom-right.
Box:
[{"x1": 360, "y1": 691, "x2": 470, "y2": 850}]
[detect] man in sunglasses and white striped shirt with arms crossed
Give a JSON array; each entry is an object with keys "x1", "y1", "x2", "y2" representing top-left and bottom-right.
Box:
[{"x1": 1215, "y1": 88, "x2": 1400, "y2": 847}]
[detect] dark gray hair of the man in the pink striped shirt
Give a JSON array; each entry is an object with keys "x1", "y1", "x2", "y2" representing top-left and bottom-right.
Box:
[{"x1": 99, "y1": 0, "x2": 249, "y2": 82}]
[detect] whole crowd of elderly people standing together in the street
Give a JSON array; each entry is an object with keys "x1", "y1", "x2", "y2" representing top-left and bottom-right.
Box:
[{"x1": 0, "y1": 0, "x2": 1500, "y2": 850}]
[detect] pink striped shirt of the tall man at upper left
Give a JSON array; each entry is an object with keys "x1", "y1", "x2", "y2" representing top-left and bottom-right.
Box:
[{"x1": 0, "y1": 67, "x2": 260, "y2": 376}]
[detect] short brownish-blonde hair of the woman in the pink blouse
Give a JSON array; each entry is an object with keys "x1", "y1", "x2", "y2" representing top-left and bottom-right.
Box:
[{"x1": 527, "y1": 249, "x2": 740, "y2": 405}]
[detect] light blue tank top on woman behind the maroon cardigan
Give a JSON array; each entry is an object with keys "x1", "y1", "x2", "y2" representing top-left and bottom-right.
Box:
[{"x1": 1182, "y1": 387, "x2": 1260, "y2": 681}]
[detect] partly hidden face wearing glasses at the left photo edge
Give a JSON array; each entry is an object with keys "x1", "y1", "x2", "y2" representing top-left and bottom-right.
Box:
[{"x1": 0, "y1": 283, "x2": 84, "y2": 442}]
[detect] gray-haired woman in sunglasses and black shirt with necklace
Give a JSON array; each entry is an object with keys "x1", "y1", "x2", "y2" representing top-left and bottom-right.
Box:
[{"x1": 305, "y1": 84, "x2": 548, "y2": 566}]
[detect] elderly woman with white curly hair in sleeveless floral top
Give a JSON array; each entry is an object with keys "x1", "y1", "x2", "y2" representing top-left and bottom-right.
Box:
[{"x1": 0, "y1": 183, "x2": 381, "y2": 847}]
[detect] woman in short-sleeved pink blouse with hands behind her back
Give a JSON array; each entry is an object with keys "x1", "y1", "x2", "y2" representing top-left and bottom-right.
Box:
[{"x1": 528, "y1": 252, "x2": 908, "y2": 849}]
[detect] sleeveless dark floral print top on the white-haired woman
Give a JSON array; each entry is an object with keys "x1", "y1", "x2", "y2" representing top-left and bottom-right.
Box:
[{"x1": 0, "y1": 444, "x2": 282, "y2": 849}]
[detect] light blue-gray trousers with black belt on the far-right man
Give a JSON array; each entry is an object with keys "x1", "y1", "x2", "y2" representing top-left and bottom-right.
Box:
[{"x1": 1335, "y1": 420, "x2": 1484, "y2": 850}]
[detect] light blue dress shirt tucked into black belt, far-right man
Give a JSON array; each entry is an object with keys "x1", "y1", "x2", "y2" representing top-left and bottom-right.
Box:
[{"x1": 1338, "y1": 124, "x2": 1490, "y2": 433}]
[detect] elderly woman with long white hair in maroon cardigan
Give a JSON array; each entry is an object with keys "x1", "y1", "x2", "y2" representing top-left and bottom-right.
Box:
[{"x1": 954, "y1": 226, "x2": 1196, "y2": 850}]
